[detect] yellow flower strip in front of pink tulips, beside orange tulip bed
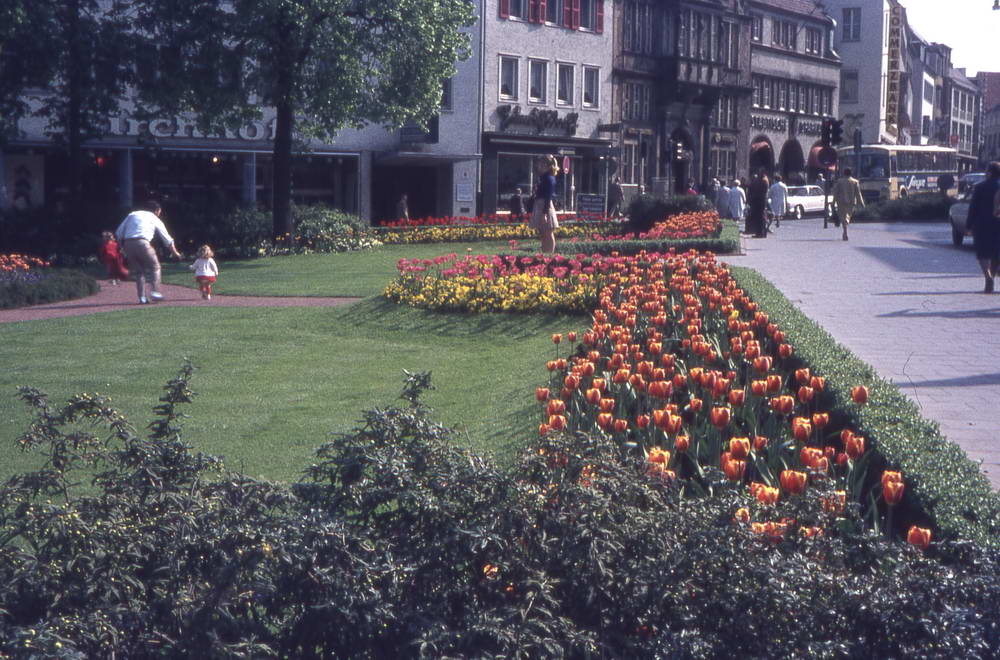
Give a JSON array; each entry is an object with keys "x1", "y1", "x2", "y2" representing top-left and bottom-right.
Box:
[{"x1": 385, "y1": 274, "x2": 604, "y2": 312}]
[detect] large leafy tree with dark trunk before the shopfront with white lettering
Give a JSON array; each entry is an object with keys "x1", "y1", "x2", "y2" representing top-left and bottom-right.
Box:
[{"x1": 127, "y1": 0, "x2": 475, "y2": 237}]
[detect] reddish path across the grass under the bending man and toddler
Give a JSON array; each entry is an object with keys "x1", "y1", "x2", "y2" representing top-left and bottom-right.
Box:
[{"x1": 0, "y1": 281, "x2": 359, "y2": 323}]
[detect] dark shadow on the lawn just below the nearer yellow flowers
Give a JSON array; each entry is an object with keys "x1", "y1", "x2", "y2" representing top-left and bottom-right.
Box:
[{"x1": 336, "y1": 296, "x2": 590, "y2": 339}]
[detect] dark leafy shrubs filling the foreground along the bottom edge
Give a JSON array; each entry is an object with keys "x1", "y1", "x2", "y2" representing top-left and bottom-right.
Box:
[{"x1": 0, "y1": 367, "x2": 1000, "y2": 658}]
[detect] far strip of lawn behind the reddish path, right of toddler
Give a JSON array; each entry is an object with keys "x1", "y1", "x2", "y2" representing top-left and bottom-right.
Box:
[{"x1": 163, "y1": 240, "x2": 538, "y2": 298}]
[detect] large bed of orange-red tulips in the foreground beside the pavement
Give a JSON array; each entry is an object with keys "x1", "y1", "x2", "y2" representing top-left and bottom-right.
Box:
[{"x1": 536, "y1": 251, "x2": 925, "y2": 537}]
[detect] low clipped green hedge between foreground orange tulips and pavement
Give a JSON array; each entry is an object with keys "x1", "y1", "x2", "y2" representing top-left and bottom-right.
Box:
[{"x1": 729, "y1": 265, "x2": 1000, "y2": 547}]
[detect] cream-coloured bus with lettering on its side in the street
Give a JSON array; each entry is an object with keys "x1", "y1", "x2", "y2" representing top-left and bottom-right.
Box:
[{"x1": 837, "y1": 144, "x2": 958, "y2": 203}]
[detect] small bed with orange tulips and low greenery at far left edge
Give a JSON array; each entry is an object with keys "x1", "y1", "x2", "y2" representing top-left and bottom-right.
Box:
[{"x1": 0, "y1": 254, "x2": 98, "y2": 309}]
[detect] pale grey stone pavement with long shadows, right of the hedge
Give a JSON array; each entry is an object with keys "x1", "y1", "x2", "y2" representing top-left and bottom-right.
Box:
[{"x1": 724, "y1": 218, "x2": 1000, "y2": 489}]
